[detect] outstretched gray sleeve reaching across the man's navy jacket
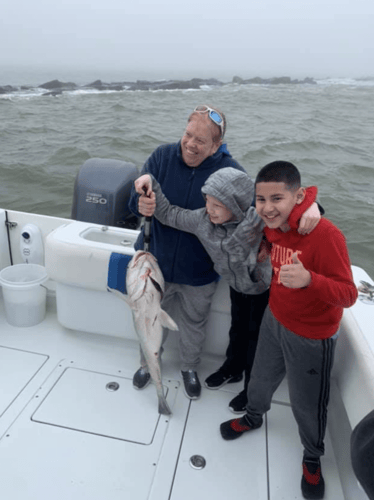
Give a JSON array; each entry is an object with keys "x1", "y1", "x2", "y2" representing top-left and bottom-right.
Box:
[{"x1": 151, "y1": 175, "x2": 205, "y2": 233}]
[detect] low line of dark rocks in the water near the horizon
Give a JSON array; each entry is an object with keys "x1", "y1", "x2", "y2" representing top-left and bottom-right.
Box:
[{"x1": 0, "y1": 76, "x2": 317, "y2": 96}]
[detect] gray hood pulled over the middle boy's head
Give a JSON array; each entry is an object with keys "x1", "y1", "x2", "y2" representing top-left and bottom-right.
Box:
[{"x1": 201, "y1": 167, "x2": 254, "y2": 221}]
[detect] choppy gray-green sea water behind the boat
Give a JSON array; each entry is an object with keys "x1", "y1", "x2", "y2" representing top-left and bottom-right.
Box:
[{"x1": 0, "y1": 73, "x2": 374, "y2": 277}]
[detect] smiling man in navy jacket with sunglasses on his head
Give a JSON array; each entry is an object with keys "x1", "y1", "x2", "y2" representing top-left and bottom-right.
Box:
[{"x1": 129, "y1": 105, "x2": 245, "y2": 399}]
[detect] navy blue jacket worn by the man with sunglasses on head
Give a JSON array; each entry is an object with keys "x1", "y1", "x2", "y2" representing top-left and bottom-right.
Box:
[{"x1": 129, "y1": 141, "x2": 245, "y2": 286}]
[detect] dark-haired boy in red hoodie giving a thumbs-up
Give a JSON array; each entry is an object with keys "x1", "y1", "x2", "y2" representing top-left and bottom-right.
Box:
[{"x1": 221, "y1": 161, "x2": 357, "y2": 499}]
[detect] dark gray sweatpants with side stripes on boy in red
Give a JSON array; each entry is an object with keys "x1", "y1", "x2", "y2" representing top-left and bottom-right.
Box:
[{"x1": 247, "y1": 306, "x2": 337, "y2": 457}]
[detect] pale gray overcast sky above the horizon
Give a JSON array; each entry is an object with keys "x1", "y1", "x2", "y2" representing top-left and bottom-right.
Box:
[{"x1": 0, "y1": 0, "x2": 374, "y2": 81}]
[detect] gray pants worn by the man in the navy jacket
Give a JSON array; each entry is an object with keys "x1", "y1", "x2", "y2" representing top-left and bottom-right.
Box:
[{"x1": 140, "y1": 282, "x2": 218, "y2": 371}]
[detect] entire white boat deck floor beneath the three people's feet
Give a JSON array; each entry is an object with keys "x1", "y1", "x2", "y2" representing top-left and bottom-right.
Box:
[{"x1": 0, "y1": 296, "x2": 366, "y2": 500}]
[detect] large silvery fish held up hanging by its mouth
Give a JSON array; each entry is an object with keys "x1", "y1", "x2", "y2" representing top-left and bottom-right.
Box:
[{"x1": 109, "y1": 250, "x2": 178, "y2": 415}]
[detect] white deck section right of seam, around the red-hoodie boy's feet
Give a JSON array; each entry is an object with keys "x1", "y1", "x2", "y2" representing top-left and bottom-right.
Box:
[{"x1": 171, "y1": 383, "x2": 344, "y2": 500}]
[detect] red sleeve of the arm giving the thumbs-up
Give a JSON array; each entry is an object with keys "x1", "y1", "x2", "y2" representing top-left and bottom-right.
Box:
[{"x1": 300, "y1": 219, "x2": 358, "y2": 308}]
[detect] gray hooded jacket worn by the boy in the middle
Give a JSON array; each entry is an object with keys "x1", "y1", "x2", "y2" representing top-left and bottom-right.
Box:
[{"x1": 152, "y1": 167, "x2": 272, "y2": 295}]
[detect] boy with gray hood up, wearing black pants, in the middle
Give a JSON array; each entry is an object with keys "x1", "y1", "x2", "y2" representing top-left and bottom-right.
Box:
[{"x1": 135, "y1": 167, "x2": 320, "y2": 413}]
